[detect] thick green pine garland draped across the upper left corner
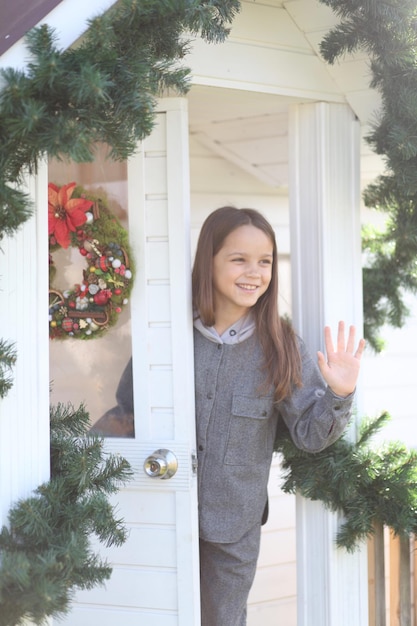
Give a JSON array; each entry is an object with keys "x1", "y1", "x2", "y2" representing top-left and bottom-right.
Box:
[{"x1": 0, "y1": 0, "x2": 240, "y2": 235}]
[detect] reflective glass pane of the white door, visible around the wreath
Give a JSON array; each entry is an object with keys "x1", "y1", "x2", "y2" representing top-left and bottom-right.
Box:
[{"x1": 49, "y1": 146, "x2": 134, "y2": 437}]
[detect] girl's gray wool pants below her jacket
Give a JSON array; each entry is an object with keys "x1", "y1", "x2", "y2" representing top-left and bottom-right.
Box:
[{"x1": 200, "y1": 524, "x2": 261, "y2": 626}]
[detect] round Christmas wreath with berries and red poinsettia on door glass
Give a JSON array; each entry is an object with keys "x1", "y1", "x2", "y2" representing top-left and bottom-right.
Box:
[{"x1": 48, "y1": 182, "x2": 133, "y2": 339}]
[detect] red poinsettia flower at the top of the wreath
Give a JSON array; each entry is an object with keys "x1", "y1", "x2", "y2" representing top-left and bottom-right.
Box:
[{"x1": 48, "y1": 183, "x2": 94, "y2": 248}]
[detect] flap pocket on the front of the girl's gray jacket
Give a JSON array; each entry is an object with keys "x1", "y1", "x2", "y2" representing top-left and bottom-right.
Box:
[{"x1": 224, "y1": 395, "x2": 273, "y2": 465}]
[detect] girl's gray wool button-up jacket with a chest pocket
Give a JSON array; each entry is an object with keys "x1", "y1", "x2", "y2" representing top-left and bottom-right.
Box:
[{"x1": 194, "y1": 330, "x2": 353, "y2": 543}]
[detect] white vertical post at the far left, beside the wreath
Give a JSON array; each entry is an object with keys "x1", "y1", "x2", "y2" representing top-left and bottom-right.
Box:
[{"x1": 0, "y1": 163, "x2": 50, "y2": 525}]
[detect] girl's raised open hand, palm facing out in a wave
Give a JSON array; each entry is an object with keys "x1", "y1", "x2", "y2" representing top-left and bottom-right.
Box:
[{"x1": 317, "y1": 322, "x2": 365, "y2": 397}]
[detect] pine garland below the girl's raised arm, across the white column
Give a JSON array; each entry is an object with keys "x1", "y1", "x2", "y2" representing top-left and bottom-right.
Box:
[{"x1": 275, "y1": 413, "x2": 417, "y2": 552}]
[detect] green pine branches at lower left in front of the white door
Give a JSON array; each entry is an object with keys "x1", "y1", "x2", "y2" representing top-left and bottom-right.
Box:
[{"x1": 0, "y1": 405, "x2": 132, "y2": 626}]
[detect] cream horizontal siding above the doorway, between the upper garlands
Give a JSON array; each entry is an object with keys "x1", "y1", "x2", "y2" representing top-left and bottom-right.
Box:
[{"x1": 189, "y1": 0, "x2": 344, "y2": 102}]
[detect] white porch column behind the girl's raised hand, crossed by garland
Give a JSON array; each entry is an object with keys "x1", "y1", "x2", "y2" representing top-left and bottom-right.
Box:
[{"x1": 289, "y1": 103, "x2": 368, "y2": 626}]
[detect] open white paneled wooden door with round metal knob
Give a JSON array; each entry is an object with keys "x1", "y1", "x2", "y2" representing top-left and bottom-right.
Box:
[{"x1": 59, "y1": 99, "x2": 200, "y2": 626}]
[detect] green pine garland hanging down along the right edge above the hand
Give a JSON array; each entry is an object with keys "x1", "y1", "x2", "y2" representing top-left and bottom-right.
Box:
[{"x1": 320, "y1": 0, "x2": 417, "y2": 351}]
